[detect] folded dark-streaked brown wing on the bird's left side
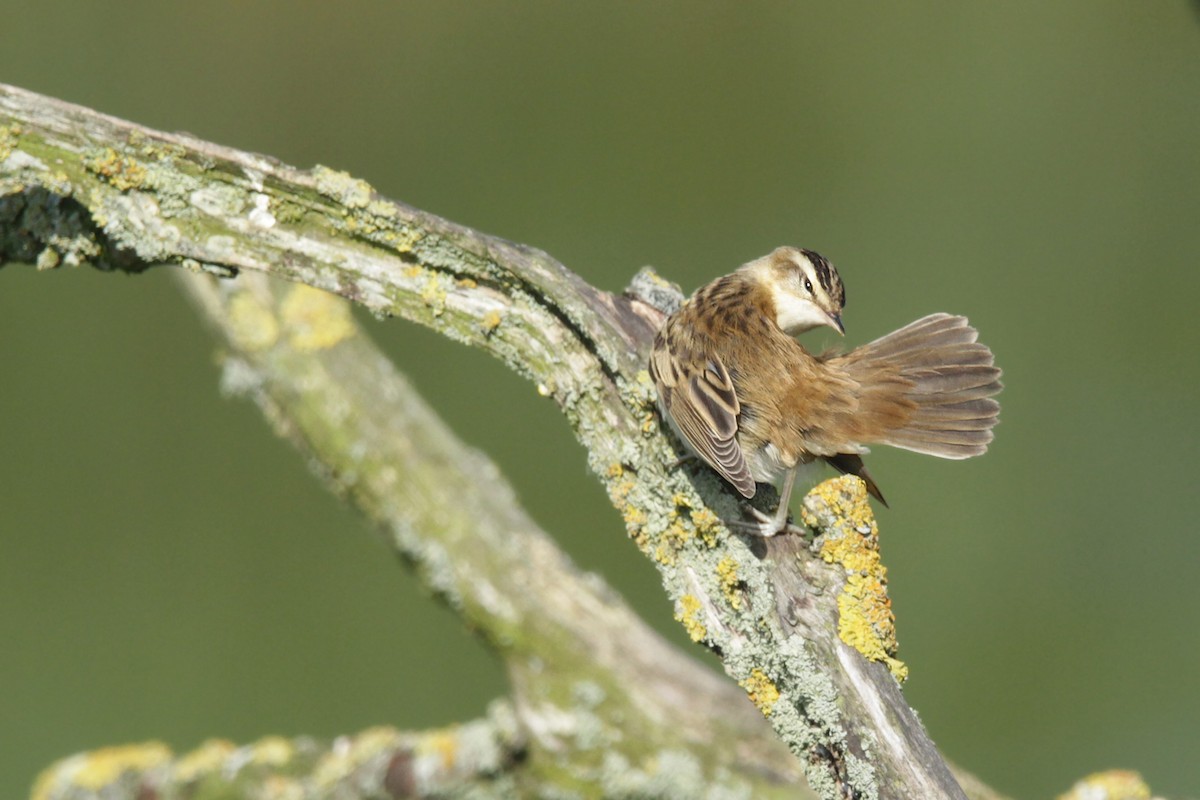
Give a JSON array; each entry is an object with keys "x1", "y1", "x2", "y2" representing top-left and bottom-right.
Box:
[{"x1": 650, "y1": 339, "x2": 755, "y2": 498}]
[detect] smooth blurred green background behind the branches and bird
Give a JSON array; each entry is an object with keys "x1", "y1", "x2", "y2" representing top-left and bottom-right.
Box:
[{"x1": 0, "y1": 0, "x2": 1200, "y2": 798}]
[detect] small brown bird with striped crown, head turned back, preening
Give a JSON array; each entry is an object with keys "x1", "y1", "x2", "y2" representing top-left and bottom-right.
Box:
[{"x1": 650, "y1": 247, "x2": 1001, "y2": 536}]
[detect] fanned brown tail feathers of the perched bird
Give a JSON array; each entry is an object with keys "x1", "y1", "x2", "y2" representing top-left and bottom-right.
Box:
[{"x1": 832, "y1": 314, "x2": 1003, "y2": 458}]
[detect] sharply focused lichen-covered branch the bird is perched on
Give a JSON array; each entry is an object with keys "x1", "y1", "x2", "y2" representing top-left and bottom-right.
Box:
[{"x1": 0, "y1": 86, "x2": 1008, "y2": 798}]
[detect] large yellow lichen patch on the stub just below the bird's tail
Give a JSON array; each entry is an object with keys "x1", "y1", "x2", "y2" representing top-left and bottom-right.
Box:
[{"x1": 804, "y1": 475, "x2": 908, "y2": 681}]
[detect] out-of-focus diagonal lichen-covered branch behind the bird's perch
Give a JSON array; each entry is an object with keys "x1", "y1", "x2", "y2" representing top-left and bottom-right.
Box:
[{"x1": 174, "y1": 275, "x2": 800, "y2": 796}]
